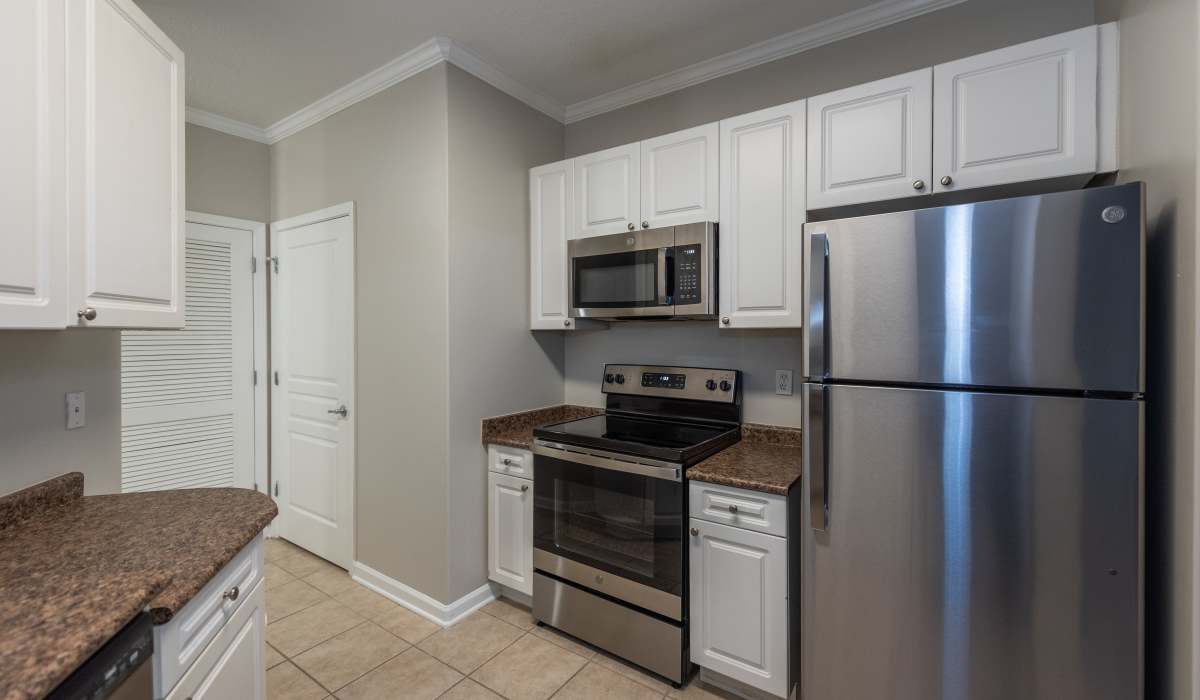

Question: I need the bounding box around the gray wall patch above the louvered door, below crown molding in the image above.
[186,124,271,221]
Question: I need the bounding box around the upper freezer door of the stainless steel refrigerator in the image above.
[805,183,1144,394]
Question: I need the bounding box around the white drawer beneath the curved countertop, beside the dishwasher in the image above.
[154,534,263,698]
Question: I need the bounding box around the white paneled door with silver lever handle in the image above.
[271,204,354,568]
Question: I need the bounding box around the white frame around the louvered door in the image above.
[184,211,270,493]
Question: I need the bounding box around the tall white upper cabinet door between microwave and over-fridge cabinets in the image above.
[719,100,805,328]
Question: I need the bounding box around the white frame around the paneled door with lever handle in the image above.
[268,202,359,563]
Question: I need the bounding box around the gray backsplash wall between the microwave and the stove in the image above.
[564,321,803,427]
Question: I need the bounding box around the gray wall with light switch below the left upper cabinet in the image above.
[0,329,121,495]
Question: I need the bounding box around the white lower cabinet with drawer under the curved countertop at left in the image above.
[154,534,266,700]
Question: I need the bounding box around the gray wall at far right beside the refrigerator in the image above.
[1097,0,1200,700]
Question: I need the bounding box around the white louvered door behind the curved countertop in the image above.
[121,222,254,491]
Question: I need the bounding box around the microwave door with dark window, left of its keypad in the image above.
[568,227,674,318]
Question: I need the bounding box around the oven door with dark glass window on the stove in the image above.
[533,444,686,621]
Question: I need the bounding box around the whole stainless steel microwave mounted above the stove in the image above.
[568,222,716,318]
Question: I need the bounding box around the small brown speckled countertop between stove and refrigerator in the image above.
[688,423,800,496]
